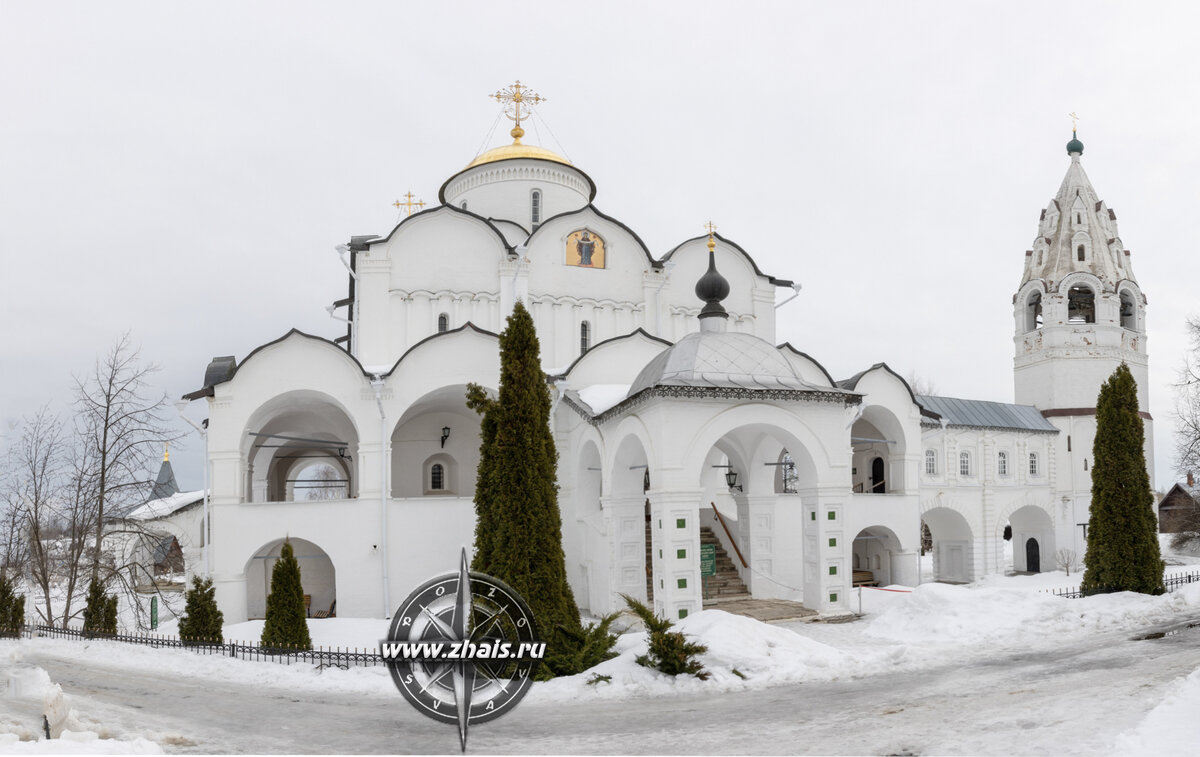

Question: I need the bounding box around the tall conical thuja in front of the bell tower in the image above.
[1081,362,1163,594]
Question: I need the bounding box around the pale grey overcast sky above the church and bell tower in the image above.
[0,0,1200,488]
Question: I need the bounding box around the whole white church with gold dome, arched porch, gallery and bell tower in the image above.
[168,83,1153,623]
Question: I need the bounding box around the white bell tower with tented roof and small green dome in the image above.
[1013,132,1154,559]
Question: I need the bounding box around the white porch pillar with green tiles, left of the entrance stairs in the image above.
[649,489,703,620]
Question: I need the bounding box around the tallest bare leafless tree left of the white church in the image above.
[76,332,178,581]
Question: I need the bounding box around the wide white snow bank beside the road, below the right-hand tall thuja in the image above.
[864,583,1200,647]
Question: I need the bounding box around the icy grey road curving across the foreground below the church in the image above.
[11,630,1200,755]
